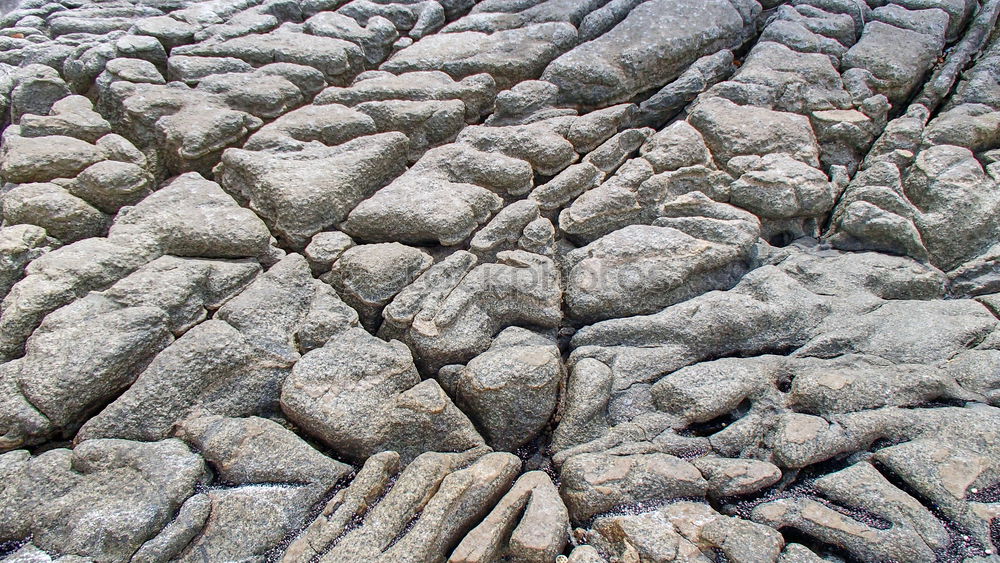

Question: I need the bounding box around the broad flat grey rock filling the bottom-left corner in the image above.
[0,440,209,560]
